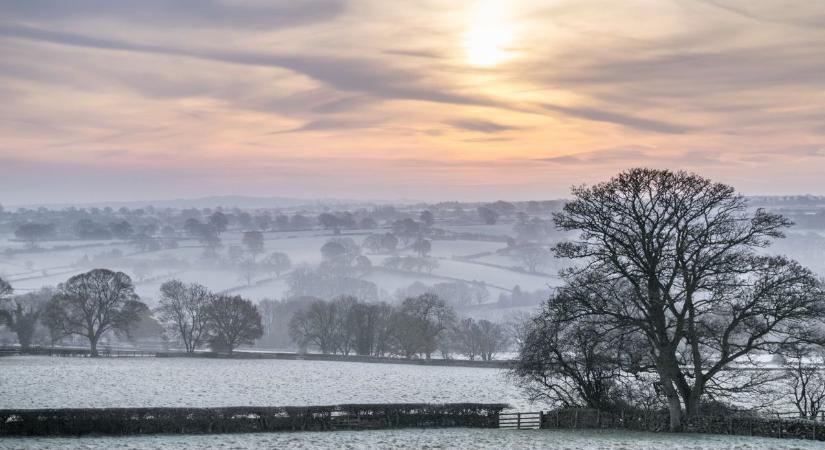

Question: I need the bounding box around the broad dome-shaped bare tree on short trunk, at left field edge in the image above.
[43,269,146,356]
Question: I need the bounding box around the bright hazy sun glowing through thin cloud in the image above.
[463,1,512,67]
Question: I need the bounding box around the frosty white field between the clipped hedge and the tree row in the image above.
[0,356,539,410]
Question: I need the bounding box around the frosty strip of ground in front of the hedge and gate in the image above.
[0,428,823,450]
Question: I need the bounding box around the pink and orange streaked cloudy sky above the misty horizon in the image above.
[0,0,825,205]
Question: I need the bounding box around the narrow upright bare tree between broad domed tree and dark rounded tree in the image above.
[157,280,213,353]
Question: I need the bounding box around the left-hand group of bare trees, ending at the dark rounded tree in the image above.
[0,269,263,356]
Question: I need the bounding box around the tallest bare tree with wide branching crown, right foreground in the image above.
[554,169,823,431]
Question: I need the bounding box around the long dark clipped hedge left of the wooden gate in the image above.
[0,403,508,436]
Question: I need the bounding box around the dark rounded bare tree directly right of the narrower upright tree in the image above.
[206,295,263,354]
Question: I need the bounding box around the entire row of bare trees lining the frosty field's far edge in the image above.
[0,269,509,361]
